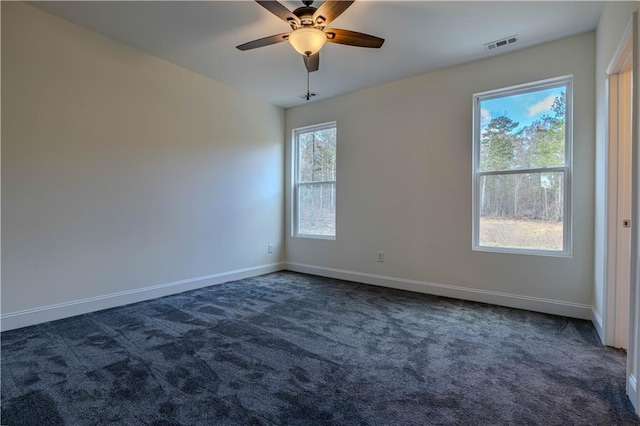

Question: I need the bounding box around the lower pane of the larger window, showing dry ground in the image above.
[478,172,564,251]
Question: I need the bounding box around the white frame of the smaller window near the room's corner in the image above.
[291,121,338,240]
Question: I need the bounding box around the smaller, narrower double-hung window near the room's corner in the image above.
[293,123,336,239]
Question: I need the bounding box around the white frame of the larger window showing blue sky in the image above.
[472,75,573,257]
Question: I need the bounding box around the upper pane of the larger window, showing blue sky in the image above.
[480,86,566,171]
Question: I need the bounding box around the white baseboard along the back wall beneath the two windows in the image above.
[286,262,592,320]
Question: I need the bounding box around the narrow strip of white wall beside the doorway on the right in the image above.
[593,1,638,343]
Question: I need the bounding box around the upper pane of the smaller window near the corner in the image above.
[298,127,336,182]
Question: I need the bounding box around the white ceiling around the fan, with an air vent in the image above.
[30,0,603,108]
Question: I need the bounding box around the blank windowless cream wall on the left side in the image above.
[2,2,284,329]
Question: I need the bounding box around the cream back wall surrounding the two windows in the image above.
[286,33,595,318]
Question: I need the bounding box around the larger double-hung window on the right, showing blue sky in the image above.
[473,76,572,256]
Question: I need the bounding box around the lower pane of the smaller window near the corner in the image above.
[298,183,336,236]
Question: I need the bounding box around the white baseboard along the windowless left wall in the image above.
[0,262,285,331]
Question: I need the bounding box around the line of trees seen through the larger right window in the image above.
[480,93,566,221]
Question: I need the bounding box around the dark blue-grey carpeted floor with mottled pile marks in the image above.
[1,272,640,426]
